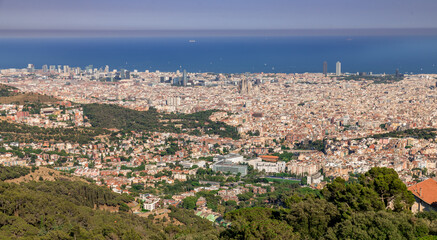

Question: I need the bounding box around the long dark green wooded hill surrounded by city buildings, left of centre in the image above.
[83,104,240,139]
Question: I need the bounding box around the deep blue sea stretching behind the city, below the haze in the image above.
[0,36,437,73]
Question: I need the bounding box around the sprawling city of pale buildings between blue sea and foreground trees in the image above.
[0,62,437,239]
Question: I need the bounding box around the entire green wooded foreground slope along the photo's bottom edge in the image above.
[0,167,437,240]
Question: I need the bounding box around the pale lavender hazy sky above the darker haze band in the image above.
[0,0,437,30]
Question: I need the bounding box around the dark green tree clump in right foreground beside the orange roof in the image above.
[221,168,430,240]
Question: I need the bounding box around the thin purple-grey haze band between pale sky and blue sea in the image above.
[0,28,437,38]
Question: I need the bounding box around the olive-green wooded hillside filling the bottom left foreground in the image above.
[0,167,218,240]
